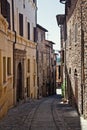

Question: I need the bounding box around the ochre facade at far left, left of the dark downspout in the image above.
[0,1,13,118]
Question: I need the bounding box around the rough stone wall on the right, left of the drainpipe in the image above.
[66,0,82,113]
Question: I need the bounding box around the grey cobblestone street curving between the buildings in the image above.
[0,96,87,130]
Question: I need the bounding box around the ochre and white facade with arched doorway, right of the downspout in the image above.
[14,0,37,102]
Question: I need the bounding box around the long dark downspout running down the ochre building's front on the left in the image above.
[12,0,16,104]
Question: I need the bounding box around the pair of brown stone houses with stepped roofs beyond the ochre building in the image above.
[37,24,55,97]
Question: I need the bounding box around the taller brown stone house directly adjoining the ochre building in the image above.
[37,24,47,97]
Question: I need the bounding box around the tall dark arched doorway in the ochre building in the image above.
[17,63,23,101]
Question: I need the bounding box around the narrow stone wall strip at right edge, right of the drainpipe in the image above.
[81,0,87,118]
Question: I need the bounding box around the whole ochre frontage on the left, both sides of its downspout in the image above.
[0,0,37,117]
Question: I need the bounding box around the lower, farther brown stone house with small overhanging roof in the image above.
[45,40,56,95]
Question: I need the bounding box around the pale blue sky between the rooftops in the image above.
[37,0,64,50]
